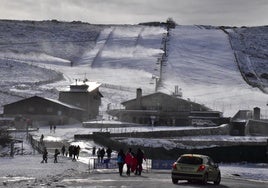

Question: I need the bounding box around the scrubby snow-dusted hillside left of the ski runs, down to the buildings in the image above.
[0,20,105,112]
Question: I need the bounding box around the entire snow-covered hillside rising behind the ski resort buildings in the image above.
[0,20,268,116]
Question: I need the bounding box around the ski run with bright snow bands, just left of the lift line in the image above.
[78,26,166,92]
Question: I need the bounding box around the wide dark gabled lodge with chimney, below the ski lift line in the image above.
[108,89,224,126]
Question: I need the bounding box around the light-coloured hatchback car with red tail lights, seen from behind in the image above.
[171,154,221,185]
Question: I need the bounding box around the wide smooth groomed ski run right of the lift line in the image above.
[161,26,267,116]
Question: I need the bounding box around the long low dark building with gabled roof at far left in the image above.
[4,96,86,128]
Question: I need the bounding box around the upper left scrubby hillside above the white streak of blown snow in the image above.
[0,20,103,61]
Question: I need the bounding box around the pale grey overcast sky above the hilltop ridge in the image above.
[0,0,268,26]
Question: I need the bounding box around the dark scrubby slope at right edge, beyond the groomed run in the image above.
[229,26,268,93]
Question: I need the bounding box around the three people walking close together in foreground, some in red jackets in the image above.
[117,148,146,176]
